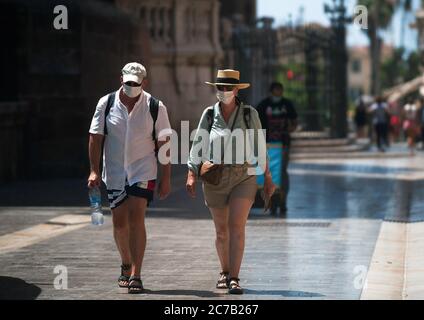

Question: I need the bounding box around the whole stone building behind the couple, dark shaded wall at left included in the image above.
[0,0,260,183]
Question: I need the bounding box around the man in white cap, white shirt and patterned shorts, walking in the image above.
[88,63,172,293]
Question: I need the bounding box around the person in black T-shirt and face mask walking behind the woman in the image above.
[257,82,297,216]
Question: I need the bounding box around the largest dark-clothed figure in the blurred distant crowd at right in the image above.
[369,97,390,152]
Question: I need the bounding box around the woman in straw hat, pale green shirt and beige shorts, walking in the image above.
[186,70,275,294]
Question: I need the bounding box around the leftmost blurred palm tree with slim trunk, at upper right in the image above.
[358,0,399,95]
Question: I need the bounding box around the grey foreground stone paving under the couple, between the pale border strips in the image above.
[0,214,380,299]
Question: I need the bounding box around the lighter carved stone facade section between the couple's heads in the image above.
[116,0,222,131]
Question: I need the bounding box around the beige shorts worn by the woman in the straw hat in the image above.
[203,165,258,208]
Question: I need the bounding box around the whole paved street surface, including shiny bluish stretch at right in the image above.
[0,145,424,300]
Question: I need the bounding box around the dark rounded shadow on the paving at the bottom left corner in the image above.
[0,276,41,300]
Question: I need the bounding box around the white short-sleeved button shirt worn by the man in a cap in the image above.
[89,88,172,190]
